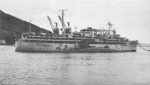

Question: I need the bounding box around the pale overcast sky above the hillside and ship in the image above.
[0,0,150,43]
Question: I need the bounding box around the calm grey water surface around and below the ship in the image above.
[0,46,150,85]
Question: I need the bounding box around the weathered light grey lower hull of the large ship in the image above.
[15,40,138,53]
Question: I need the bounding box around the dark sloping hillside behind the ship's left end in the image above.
[0,10,50,44]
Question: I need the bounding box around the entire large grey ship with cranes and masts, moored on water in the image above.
[15,10,138,53]
